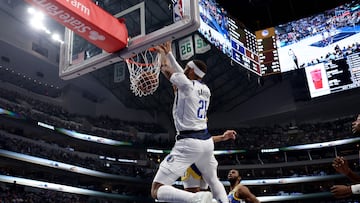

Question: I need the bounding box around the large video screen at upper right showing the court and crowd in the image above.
[275,1,360,72]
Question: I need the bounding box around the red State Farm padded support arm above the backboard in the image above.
[25,0,128,53]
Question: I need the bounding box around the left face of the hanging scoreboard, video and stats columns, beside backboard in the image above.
[199,0,261,75]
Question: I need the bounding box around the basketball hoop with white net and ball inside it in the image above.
[125,48,161,97]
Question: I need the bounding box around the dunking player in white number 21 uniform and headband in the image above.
[151,42,228,203]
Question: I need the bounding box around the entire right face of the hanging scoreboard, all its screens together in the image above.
[264,0,360,98]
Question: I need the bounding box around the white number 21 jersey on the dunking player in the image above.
[170,72,211,133]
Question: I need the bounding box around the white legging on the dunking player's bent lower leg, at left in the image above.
[157,185,195,203]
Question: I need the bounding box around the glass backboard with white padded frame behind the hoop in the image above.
[59,0,200,80]
